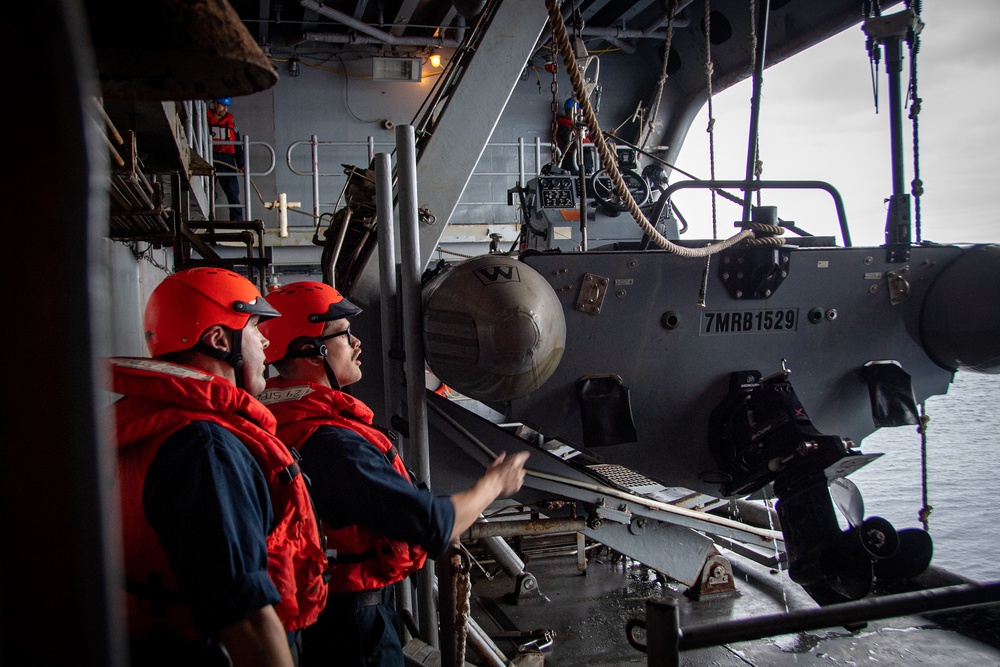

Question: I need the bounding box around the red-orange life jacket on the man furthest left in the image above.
[112,358,328,639]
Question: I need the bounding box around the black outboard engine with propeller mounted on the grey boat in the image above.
[703,370,932,604]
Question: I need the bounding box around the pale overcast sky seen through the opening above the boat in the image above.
[675,0,1000,246]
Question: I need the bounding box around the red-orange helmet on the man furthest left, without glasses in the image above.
[143,267,281,357]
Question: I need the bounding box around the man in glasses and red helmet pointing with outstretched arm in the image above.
[261,282,527,666]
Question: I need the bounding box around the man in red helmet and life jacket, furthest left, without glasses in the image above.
[112,268,327,665]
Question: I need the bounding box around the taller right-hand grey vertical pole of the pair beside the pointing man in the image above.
[396,125,438,648]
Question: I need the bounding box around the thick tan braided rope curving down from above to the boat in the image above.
[545,0,753,257]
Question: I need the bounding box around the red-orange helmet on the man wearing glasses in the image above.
[260,281,361,364]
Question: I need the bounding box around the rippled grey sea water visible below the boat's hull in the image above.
[850,371,1000,581]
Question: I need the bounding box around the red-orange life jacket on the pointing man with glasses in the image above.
[260,377,427,593]
